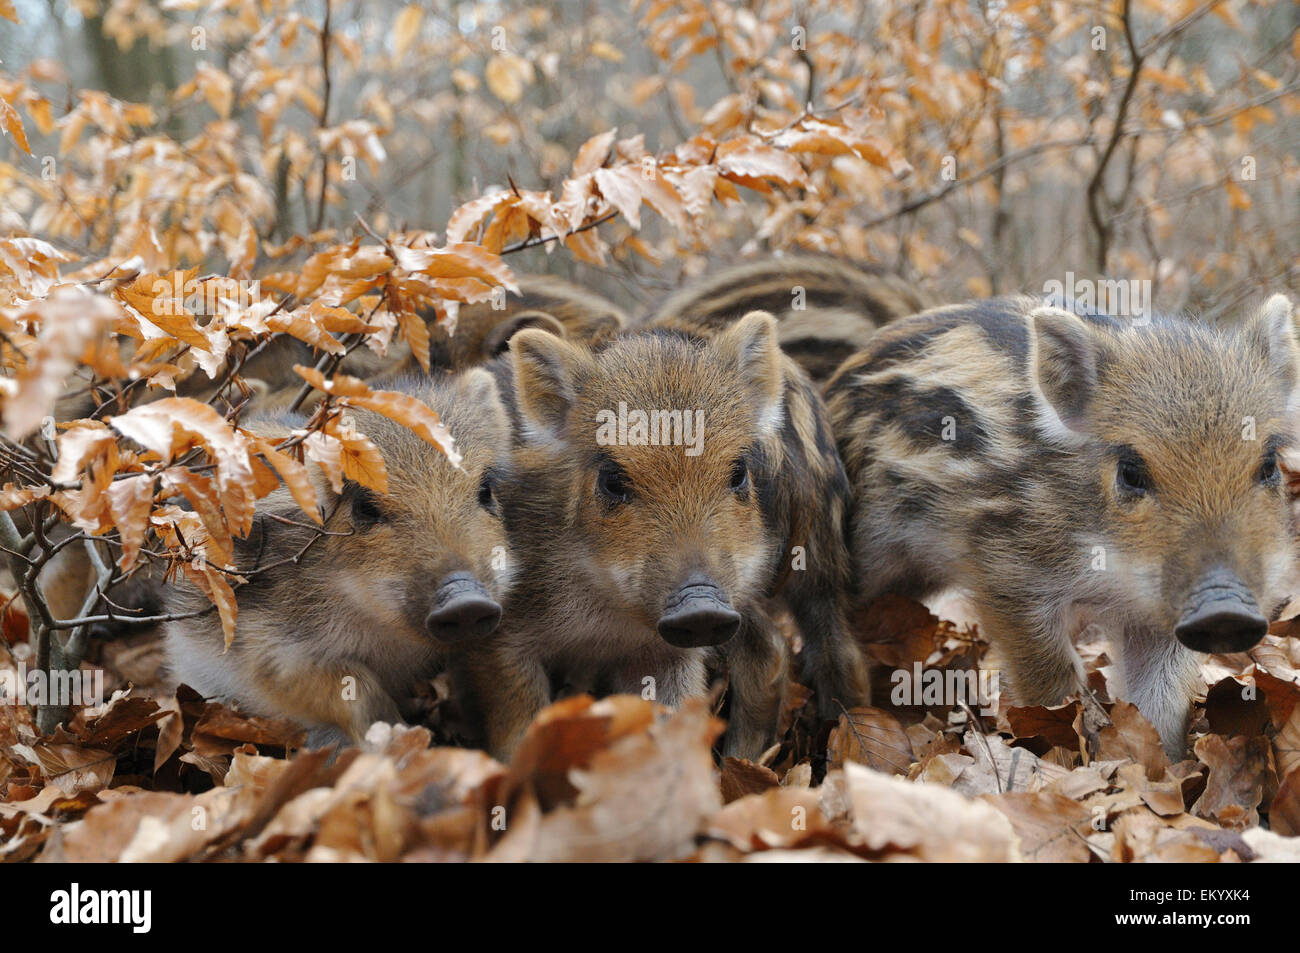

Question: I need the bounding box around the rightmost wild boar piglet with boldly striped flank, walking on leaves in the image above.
[827,295,1297,757]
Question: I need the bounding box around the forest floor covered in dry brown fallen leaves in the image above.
[0,599,1300,862]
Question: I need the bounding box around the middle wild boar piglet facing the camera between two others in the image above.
[458,312,867,757]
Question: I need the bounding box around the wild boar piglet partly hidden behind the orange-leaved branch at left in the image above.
[166,369,511,745]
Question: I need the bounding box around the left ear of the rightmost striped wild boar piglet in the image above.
[1027,306,1097,442]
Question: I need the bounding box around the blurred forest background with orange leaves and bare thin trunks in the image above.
[0,0,1300,316]
